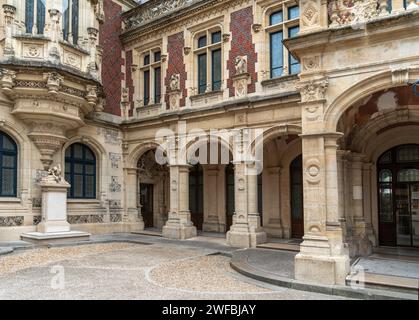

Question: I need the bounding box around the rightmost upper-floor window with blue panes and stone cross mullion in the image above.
[266,2,300,79]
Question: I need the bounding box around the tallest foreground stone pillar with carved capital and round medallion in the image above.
[295,79,349,285]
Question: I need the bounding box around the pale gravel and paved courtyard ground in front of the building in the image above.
[0,243,348,299]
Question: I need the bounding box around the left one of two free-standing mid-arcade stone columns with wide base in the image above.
[163,164,197,240]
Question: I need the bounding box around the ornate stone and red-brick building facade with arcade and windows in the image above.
[0,0,419,284]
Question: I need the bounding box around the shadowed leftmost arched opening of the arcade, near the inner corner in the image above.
[137,149,169,229]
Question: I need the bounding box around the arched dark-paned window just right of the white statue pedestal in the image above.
[65,143,96,199]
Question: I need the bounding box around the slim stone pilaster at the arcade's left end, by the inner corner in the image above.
[124,168,144,232]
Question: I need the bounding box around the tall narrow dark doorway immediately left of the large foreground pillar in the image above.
[290,155,304,238]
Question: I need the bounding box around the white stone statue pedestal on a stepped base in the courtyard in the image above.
[21,178,90,244]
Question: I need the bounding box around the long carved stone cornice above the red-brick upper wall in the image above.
[120,0,253,45]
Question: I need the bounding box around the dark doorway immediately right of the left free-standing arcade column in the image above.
[189,164,204,230]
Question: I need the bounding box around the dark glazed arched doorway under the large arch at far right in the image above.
[377,145,419,247]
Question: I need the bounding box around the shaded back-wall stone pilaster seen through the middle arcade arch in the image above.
[202,165,222,232]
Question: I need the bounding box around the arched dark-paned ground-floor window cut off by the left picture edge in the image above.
[0,132,17,197]
